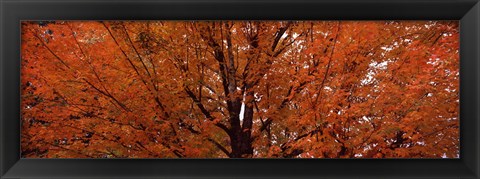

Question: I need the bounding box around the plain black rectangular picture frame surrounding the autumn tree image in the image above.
[0,0,480,179]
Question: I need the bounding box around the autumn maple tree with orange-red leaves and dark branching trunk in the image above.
[21,21,460,158]
